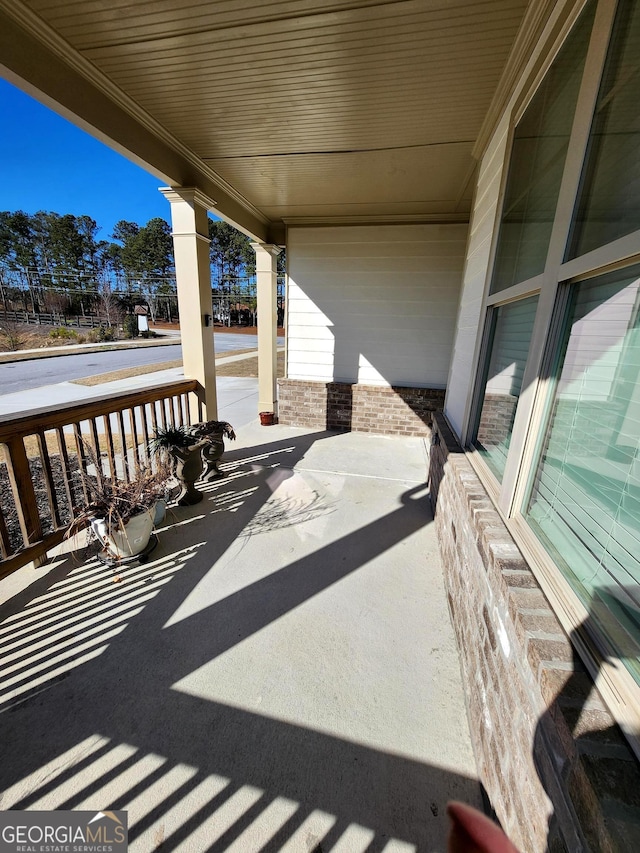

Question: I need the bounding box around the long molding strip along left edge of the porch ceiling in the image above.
[0,0,269,231]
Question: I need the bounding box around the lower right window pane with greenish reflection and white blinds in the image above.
[525,267,640,682]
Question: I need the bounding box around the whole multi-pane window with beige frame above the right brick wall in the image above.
[468,0,640,736]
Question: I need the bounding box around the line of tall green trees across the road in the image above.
[0,210,284,324]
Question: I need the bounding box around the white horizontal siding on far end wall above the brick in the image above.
[287,225,467,388]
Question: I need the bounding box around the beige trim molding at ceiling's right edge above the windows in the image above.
[472,0,585,160]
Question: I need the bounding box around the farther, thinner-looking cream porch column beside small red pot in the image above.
[251,243,281,416]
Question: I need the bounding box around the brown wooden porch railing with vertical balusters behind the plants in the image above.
[0,380,202,578]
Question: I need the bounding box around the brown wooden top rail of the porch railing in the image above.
[0,379,198,442]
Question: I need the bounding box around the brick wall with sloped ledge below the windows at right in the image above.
[430,414,640,853]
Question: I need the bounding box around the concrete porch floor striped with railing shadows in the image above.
[0,423,481,853]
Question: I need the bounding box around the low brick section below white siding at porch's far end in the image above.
[278,379,445,436]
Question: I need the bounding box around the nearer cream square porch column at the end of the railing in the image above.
[160,187,218,421]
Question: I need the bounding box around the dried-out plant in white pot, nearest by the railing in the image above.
[67,463,170,562]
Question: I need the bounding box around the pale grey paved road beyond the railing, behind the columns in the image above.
[0,332,258,395]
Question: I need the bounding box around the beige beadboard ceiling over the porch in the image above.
[0,0,540,243]
